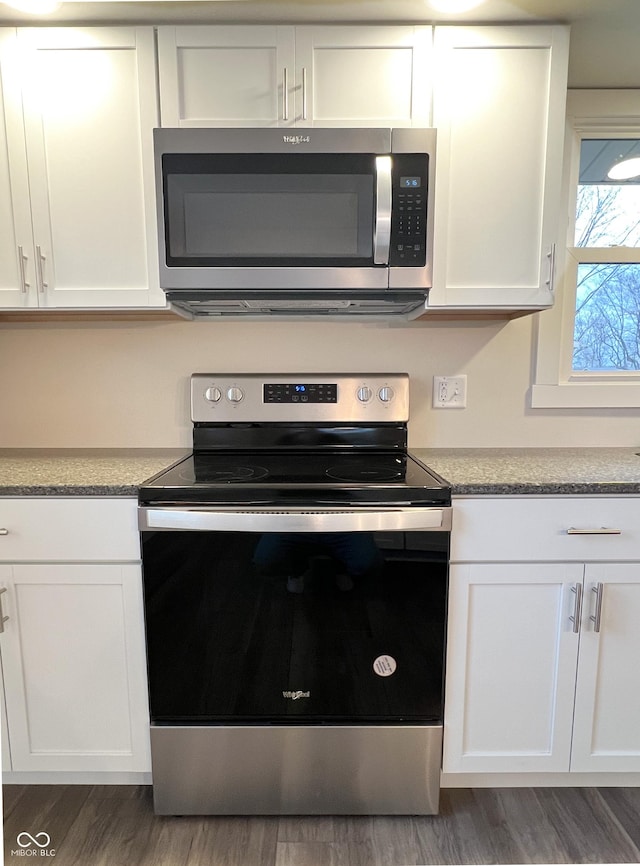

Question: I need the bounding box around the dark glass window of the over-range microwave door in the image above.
[162,154,375,267]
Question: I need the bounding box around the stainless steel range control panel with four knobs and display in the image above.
[191,373,409,424]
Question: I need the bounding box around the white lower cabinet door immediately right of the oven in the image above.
[443,563,583,773]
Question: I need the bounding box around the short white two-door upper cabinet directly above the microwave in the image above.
[158,25,432,127]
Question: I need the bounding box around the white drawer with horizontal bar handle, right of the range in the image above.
[451,496,640,562]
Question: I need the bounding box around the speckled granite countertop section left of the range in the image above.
[0,448,189,496]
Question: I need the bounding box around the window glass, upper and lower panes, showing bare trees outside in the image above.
[572,139,640,372]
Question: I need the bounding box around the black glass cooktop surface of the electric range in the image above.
[140,451,451,503]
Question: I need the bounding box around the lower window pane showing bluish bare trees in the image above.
[573,264,640,372]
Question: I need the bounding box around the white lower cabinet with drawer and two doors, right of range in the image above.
[443,497,640,773]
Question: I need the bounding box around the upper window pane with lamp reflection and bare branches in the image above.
[574,139,640,247]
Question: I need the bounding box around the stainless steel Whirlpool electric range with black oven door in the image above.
[139,373,451,814]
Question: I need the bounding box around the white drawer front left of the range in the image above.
[0,497,140,562]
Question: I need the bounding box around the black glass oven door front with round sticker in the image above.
[143,532,448,724]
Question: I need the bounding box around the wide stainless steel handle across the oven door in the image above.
[138,506,451,532]
